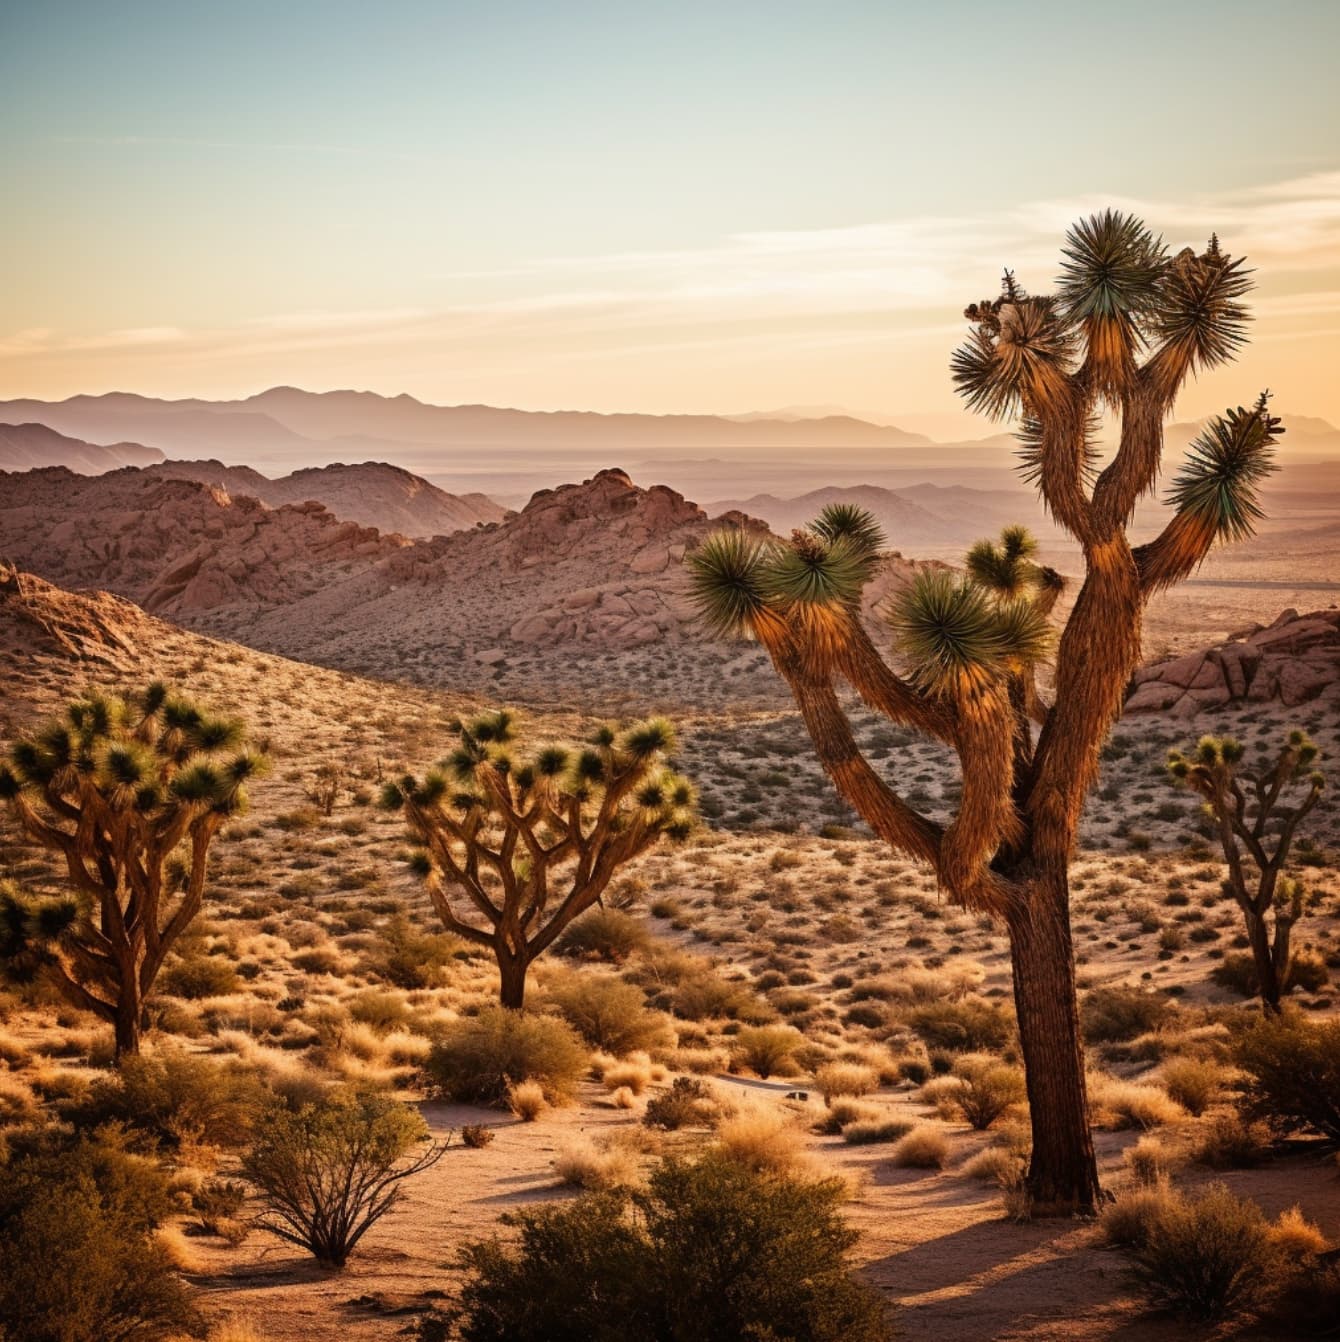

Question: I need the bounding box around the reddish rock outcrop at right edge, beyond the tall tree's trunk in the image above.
[1125,608,1340,717]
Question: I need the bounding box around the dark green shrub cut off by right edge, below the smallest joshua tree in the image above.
[1234,1013,1340,1142]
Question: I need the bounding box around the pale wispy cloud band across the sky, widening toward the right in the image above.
[10,170,1340,386]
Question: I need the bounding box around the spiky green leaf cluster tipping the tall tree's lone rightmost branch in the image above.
[1168,393,1284,541]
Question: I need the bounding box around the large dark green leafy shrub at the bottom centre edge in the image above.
[460,1155,889,1342]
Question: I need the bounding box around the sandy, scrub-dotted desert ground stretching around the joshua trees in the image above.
[0,539,1340,1342]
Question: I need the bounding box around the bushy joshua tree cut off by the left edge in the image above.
[0,684,263,1057]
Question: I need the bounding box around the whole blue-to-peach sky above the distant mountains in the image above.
[0,0,1340,433]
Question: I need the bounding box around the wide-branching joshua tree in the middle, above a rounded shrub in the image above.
[382,709,693,1007]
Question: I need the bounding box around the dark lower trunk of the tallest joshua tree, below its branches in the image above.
[1009,867,1099,1216]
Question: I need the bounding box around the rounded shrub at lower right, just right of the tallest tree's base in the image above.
[1131,1184,1281,1322]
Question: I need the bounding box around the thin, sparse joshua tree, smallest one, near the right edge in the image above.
[1168,730,1327,1016]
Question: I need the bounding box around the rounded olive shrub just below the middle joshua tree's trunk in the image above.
[424,1007,588,1104]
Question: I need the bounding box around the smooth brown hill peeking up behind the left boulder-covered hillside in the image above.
[142,460,506,538]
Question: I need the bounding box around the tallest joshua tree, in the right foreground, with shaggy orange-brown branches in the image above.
[692,212,1278,1213]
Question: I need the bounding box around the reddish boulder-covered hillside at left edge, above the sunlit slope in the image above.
[0,467,409,617]
